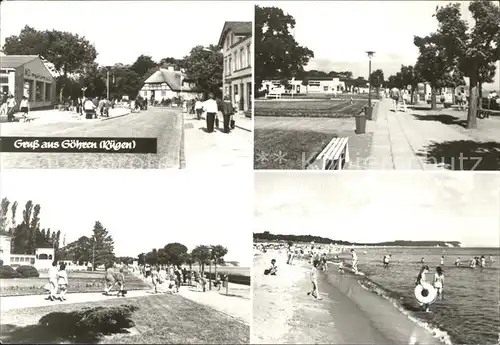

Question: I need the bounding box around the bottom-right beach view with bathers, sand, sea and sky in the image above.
[251,172,500,345]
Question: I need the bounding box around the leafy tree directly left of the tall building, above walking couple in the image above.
[184,45,224,97]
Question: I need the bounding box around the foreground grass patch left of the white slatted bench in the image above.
[254,128,335,170]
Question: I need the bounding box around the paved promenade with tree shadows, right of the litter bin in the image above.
[363,99,500,170]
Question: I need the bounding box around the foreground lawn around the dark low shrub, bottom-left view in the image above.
[0,294,250,344]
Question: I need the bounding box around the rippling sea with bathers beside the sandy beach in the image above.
[340,247,500,345]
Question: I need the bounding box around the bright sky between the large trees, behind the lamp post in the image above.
[259,0,500,90]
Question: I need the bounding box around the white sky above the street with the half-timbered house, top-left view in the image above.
[0,1,254,65]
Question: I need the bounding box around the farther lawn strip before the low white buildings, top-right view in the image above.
[255,100,366,118]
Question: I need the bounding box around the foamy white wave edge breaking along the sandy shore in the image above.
[358,275,453,345]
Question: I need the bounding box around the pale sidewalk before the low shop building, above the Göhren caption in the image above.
[0,108,130,124]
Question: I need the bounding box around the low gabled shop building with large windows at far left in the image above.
[0,55,56,109]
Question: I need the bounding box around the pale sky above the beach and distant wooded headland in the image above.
[254,171,500,247]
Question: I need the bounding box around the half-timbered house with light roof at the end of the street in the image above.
[139,67,199,101]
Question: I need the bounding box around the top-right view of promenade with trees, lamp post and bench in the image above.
[254,1,500,171]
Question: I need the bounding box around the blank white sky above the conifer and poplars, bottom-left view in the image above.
[0,170,253,267]
